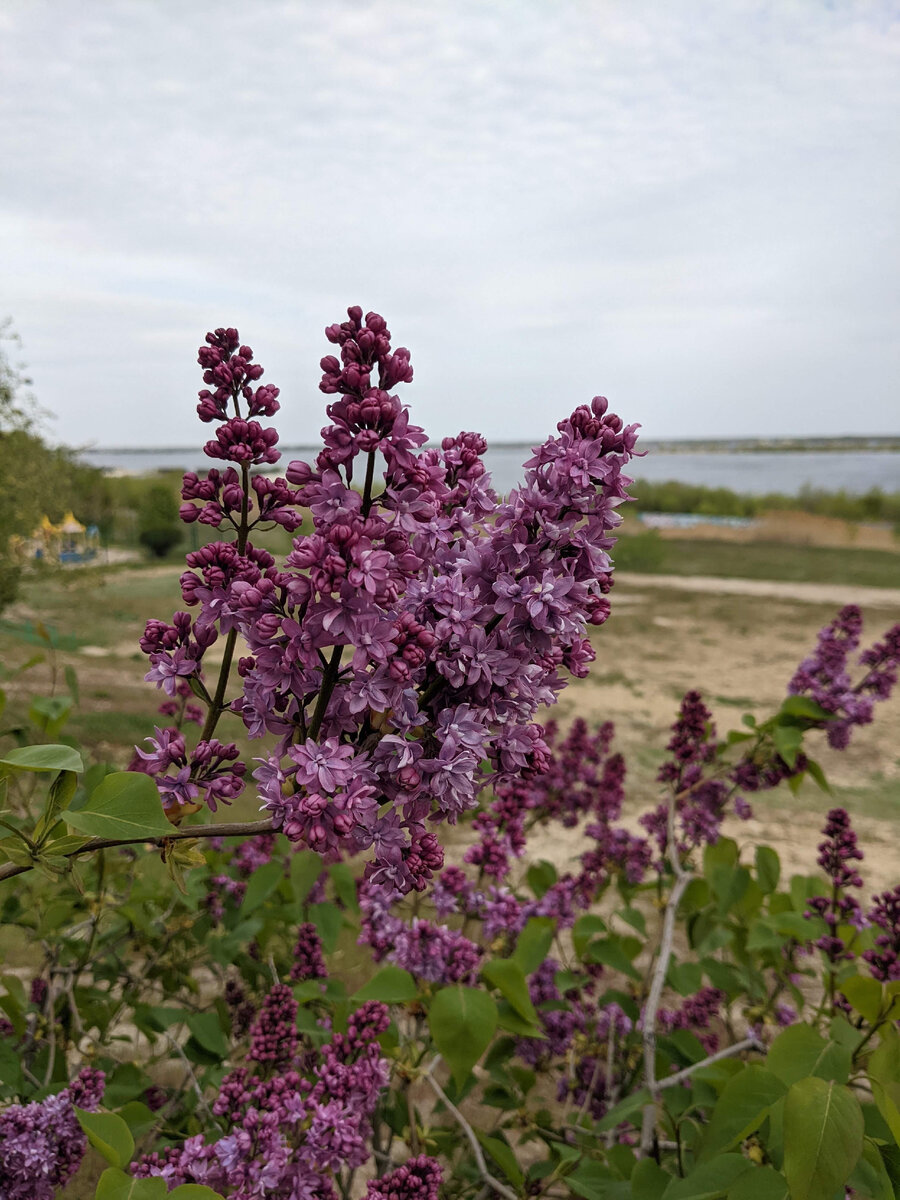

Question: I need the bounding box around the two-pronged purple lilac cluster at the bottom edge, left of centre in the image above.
[132,985,388,1200]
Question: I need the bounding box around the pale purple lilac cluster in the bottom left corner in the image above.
[0,1068,106,1200]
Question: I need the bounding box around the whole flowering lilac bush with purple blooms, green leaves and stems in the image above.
[0,308,900,1200]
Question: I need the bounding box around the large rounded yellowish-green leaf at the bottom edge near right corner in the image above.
[785,1079,863,1200]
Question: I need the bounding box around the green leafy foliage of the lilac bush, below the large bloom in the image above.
[0,609,900,1200]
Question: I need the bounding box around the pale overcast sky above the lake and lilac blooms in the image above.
[0,0,900,446]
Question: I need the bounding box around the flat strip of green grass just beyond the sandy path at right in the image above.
[613,534,900,588]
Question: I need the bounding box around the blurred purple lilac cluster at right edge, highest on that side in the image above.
[788,605,900,750]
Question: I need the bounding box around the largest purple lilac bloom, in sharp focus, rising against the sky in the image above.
[142,308,635,893]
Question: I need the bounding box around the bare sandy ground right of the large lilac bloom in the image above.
[528,572,900,890]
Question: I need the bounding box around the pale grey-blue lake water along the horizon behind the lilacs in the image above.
[80,445,900,496]
